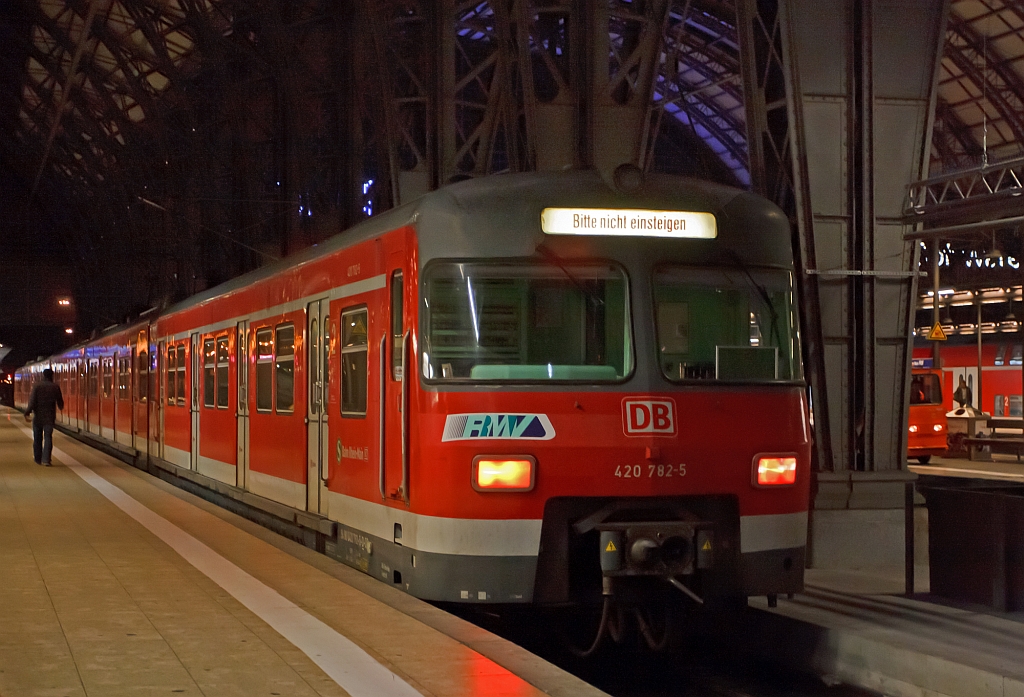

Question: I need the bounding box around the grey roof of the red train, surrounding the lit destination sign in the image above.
[18,170,792,367]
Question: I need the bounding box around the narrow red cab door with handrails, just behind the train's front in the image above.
[380,264,409,504]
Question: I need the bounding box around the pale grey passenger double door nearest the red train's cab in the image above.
[306,298,330,516]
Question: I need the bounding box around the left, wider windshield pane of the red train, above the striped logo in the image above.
[423,263,633,383]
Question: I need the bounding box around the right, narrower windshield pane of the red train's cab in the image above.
[654,267,802,382]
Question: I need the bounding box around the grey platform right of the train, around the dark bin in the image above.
[727,454,1024,697]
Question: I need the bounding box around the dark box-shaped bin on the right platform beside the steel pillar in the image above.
[921,486,1024,612]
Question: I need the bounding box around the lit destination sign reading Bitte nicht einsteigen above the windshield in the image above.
[541,208,718,239]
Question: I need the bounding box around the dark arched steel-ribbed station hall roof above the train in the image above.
[0,0,1024,329]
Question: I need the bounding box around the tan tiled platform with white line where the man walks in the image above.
[0,408,604,697]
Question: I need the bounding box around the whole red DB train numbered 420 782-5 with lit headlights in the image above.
[16,172,810,618]
